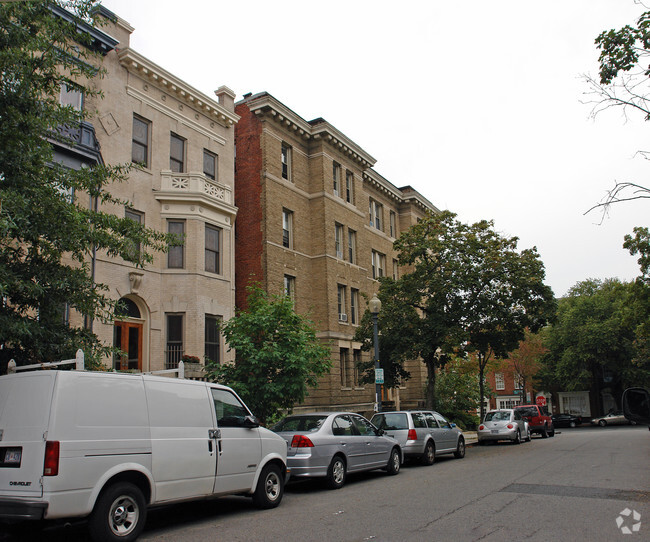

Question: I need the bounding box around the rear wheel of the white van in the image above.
[88,482,147,542]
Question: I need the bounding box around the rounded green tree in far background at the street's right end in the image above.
[541,279,650,410]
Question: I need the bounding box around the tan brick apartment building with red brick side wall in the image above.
[235,93,437,413]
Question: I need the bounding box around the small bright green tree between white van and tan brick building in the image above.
[206,284,331,423]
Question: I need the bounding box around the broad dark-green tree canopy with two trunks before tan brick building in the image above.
[352,211,555,416]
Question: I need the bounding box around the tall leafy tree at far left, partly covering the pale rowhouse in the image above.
[0,0,167,372]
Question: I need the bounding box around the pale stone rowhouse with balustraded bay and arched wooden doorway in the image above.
[63,8,238,371]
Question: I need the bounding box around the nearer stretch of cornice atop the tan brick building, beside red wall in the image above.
[239,92,377,169]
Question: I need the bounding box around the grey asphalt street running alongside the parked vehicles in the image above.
[5,426,650,542]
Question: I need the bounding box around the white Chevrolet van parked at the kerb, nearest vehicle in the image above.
[0,370,288,542]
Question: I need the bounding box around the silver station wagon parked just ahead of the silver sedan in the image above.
[371,410,465,465]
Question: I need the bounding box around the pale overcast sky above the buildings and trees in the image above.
[103,0,650,296]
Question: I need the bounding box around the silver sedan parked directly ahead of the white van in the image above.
[272,412,403,489]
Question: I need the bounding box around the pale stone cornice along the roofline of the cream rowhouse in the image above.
[117,48,239,128]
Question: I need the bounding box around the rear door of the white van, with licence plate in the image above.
[0,371,57,498]
